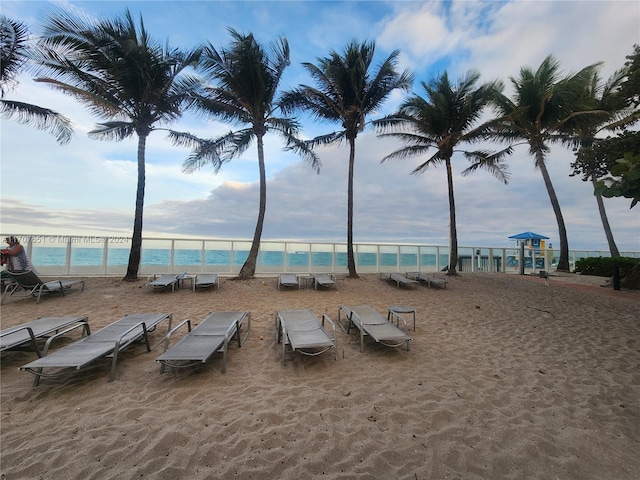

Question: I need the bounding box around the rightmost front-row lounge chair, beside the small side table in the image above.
[338,305,411,352]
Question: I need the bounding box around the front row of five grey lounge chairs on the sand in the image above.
[0,305,415,387]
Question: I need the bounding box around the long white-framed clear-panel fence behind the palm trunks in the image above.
[2,235,640,276]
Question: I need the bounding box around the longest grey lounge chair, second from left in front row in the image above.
[20,313,173,387]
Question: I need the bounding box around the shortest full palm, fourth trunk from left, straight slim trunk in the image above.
[373,71,511,275]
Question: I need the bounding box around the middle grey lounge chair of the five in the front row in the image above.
[156,312,251,373]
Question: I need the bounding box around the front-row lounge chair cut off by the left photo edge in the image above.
[0,317,91,357]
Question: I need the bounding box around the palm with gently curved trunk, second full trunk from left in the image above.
[175,29,320,279]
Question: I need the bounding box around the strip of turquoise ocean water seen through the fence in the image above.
[31,247,448,267]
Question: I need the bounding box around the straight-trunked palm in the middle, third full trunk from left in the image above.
[283,41,413,278]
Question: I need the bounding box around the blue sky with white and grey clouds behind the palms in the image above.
[0,0,640,252]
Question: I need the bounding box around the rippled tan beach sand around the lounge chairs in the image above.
[0,273,640,480]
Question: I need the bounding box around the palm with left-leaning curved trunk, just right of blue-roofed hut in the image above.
[495,55,601,272]
